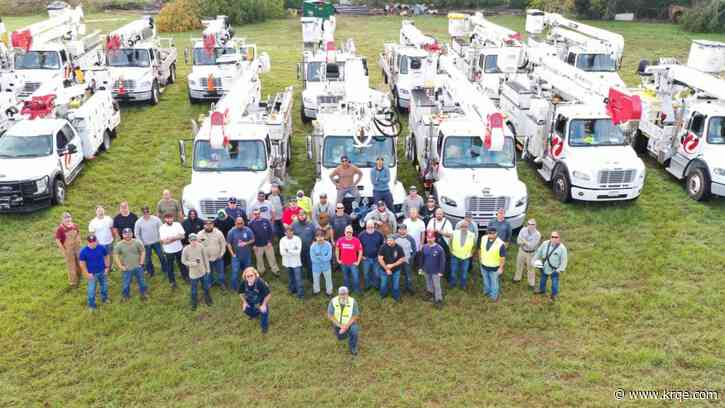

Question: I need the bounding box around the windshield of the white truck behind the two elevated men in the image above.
[322,136,395,168]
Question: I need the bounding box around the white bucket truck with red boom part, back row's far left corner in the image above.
[1,2,102,99]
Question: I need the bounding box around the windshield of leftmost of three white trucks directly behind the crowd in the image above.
[194,140,267,171]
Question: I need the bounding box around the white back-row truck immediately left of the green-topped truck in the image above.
[184,16,269,103]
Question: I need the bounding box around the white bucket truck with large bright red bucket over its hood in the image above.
[501,52,645,202]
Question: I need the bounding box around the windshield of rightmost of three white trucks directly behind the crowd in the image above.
[443,136,514,168]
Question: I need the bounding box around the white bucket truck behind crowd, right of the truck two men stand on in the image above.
[406,56,528,230]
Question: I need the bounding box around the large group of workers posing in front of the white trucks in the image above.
[55,177,567,354]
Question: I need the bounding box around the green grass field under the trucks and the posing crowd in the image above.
[0,14,725,407]
